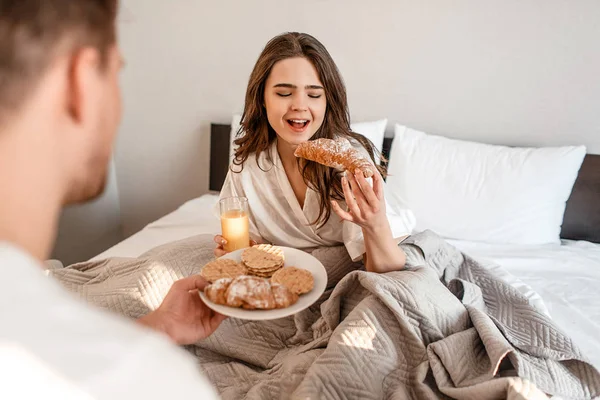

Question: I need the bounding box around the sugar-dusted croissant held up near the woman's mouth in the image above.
[294,138,373,178]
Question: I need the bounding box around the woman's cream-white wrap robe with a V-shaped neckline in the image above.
[215,141,415,261]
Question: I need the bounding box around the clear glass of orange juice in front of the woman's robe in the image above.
[219,197,250,253]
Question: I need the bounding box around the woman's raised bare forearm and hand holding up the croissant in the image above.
[332,171,406,273]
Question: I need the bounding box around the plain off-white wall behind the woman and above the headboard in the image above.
[116,0,600,234]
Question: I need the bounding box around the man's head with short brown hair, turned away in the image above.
[0,0,122,203]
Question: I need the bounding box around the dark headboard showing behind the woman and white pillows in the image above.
[209,124,600,243]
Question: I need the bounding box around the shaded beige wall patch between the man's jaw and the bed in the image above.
[52,158,123,265]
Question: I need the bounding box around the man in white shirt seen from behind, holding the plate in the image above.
[0,0,224,399]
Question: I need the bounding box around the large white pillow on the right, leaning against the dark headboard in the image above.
[387,125,586,244]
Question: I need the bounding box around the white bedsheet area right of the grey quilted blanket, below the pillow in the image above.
[449,240,600,369]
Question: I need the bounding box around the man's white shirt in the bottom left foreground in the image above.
[0,242,217,399]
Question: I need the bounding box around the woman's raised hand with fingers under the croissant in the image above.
[331,170,389,233]
